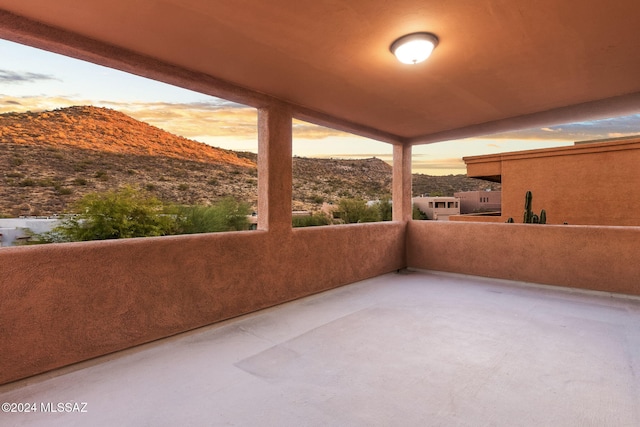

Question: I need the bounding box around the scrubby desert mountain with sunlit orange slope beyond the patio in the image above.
[0,106,495,216]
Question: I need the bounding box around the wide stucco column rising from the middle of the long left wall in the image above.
[258,105,293,231]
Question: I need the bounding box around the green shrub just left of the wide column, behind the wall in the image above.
[176,197,251,234]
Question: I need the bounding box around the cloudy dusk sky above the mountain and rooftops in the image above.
[0,40,640,175]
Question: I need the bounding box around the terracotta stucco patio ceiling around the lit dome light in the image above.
[0,0,640,143]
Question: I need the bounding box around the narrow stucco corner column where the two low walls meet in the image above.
[393,144,412,221]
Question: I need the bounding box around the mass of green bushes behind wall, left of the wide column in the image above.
[28,186,250,244]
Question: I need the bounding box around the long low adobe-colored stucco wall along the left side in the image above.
[0,222,405,384]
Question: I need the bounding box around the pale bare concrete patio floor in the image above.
[0,271,640,426]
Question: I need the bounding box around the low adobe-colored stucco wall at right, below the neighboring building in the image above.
[407,221,640,295]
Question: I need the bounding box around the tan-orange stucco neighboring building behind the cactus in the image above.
[464,138,640,226]
